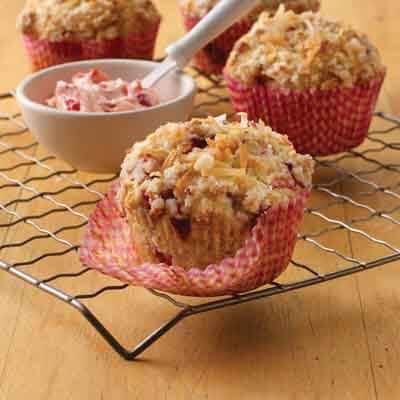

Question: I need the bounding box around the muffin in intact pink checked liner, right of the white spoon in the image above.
[225,7,386,156]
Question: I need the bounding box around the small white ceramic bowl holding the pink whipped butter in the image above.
[16,60,196,173]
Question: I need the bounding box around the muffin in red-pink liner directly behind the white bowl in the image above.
[17,0,161,70]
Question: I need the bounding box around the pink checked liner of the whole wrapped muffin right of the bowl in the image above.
[225,73,385,156]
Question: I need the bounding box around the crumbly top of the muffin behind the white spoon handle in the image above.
[180,0,320,18]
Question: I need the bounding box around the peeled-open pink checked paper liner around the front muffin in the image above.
[80,182,309,297]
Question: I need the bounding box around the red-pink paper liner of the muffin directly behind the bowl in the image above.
[22,21,160,71]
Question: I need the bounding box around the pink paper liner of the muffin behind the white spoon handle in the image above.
[182,11,253,75]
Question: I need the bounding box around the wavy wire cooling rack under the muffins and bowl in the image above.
[0,70,400,360]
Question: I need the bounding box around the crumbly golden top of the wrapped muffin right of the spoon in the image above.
[226,6,385,89]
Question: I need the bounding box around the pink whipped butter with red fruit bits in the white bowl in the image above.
[46,69,160,112]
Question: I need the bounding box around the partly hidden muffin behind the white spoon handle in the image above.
[180,0,320,74]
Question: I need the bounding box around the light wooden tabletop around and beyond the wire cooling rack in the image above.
[0,0,400,400]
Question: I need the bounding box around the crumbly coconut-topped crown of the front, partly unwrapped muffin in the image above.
[120,114,314,221]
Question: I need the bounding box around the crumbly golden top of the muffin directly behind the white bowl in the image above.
[17,0,160,41]
